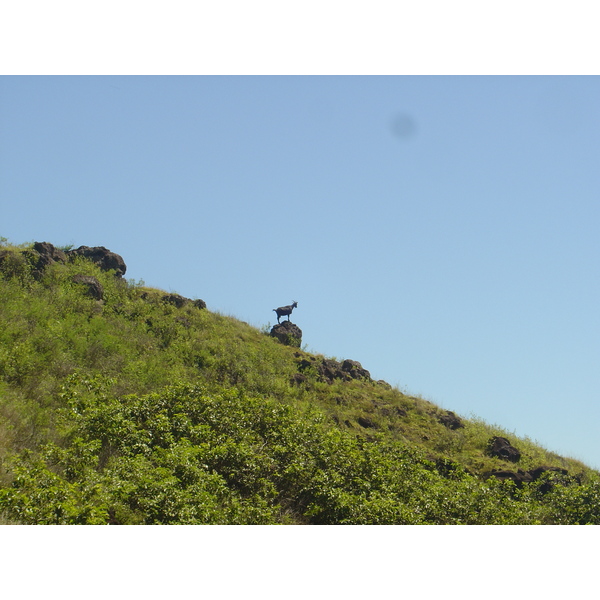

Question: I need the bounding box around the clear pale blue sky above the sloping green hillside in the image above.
[0,76,600,468]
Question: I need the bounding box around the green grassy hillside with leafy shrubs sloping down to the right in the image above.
[0,242,600,524]
